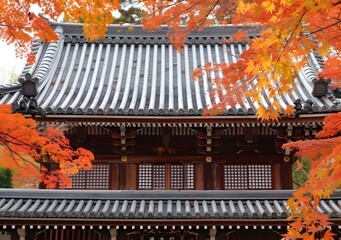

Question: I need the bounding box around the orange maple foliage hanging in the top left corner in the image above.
[0,0,119,63]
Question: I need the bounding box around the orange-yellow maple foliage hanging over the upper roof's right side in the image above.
[143,0,341,121]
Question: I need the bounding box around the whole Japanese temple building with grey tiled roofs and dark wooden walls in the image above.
[0,22,341,240]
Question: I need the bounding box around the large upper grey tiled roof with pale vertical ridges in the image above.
[0,23,339,116]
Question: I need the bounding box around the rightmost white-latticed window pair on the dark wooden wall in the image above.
[224,164,272,189]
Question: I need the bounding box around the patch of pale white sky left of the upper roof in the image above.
[0,42,25,85]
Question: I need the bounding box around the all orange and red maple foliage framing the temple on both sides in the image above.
[0,0,341,239]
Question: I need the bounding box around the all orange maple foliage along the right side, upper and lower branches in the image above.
[139,0,341,240]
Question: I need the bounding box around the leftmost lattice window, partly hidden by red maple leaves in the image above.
[66,164,110,189]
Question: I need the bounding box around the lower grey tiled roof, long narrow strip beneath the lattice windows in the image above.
[0,189,341,220]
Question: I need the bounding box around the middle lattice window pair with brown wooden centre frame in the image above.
[138,164,194,189]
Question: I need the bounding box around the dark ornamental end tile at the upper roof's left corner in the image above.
[12,73,46,117]
